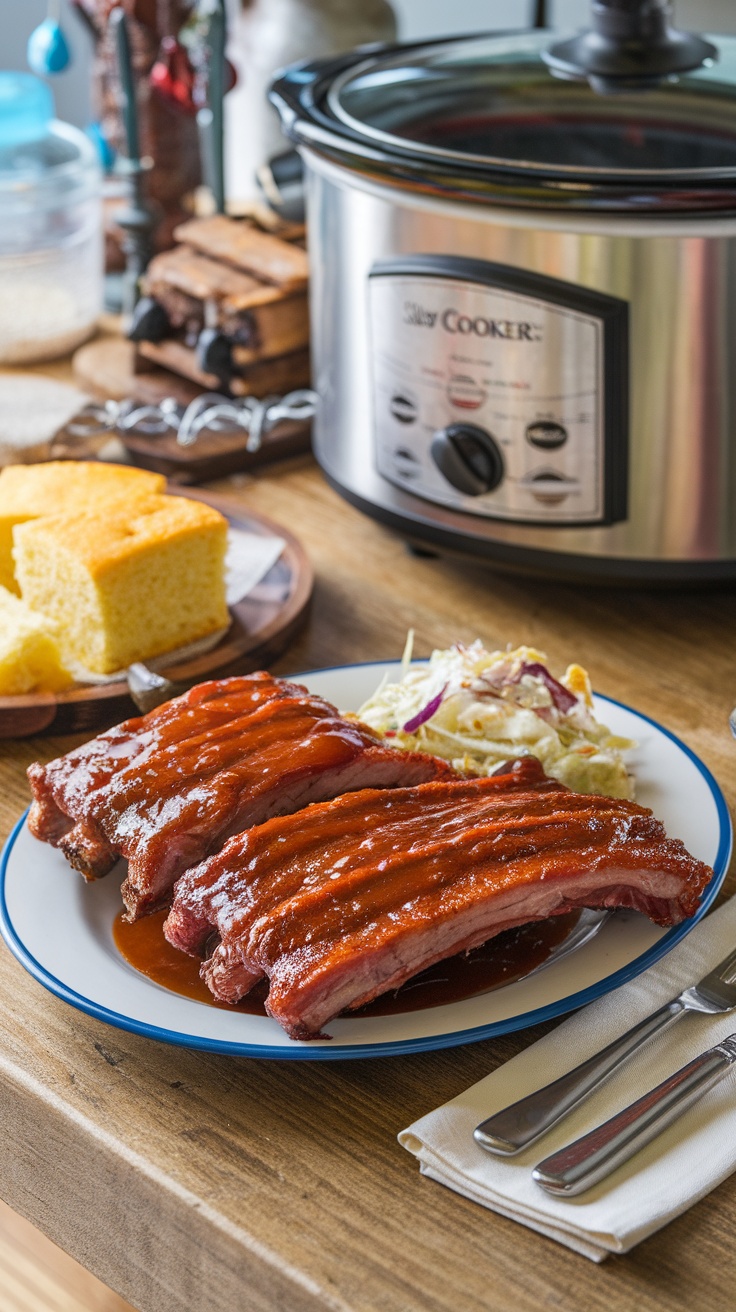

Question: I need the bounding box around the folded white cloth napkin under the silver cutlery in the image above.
[399,897,736,1262]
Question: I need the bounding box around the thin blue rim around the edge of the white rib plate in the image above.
[0,682,733,1061]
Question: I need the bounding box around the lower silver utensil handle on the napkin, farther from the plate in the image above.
[531,1044,736,1197]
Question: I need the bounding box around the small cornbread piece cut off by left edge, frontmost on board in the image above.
[0,588,72,697]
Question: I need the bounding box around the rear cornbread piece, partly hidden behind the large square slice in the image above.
[0,461,167,592]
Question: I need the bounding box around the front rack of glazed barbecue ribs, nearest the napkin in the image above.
[164,757,712,1039]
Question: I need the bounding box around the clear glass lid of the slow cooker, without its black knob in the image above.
[327,31,736,180]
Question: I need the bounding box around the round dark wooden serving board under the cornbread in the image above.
[0,487,314,739]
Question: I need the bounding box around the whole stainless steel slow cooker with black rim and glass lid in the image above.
[272,0,736,583]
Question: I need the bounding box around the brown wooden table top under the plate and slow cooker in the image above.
[0,458,736,1312]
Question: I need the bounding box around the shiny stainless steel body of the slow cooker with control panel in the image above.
[303,148,736,581]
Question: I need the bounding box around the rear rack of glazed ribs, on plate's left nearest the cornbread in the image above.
[29,673,454,920]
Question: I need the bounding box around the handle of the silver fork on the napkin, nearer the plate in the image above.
[474,998,685,1157]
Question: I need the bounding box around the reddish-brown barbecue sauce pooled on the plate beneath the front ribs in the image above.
[113,911,580,1015]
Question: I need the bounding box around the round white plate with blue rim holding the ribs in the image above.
[0,663,732,1061]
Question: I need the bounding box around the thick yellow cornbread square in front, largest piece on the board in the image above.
[13,496,228,674]
